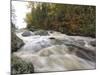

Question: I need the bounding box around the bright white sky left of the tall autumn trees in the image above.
[12,1,29,29]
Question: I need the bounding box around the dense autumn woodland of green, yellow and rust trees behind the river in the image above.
[25,2,96,37]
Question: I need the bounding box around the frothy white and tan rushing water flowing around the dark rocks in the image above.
[14,29,95,72]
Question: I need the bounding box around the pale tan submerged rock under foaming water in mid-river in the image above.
[38,45,68,56]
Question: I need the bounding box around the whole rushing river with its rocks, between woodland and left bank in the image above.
[13,30,96,72]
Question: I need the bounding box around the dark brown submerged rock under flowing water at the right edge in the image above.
[69,46,96,62]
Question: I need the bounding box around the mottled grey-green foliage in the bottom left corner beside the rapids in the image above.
[11,55,34,75]
